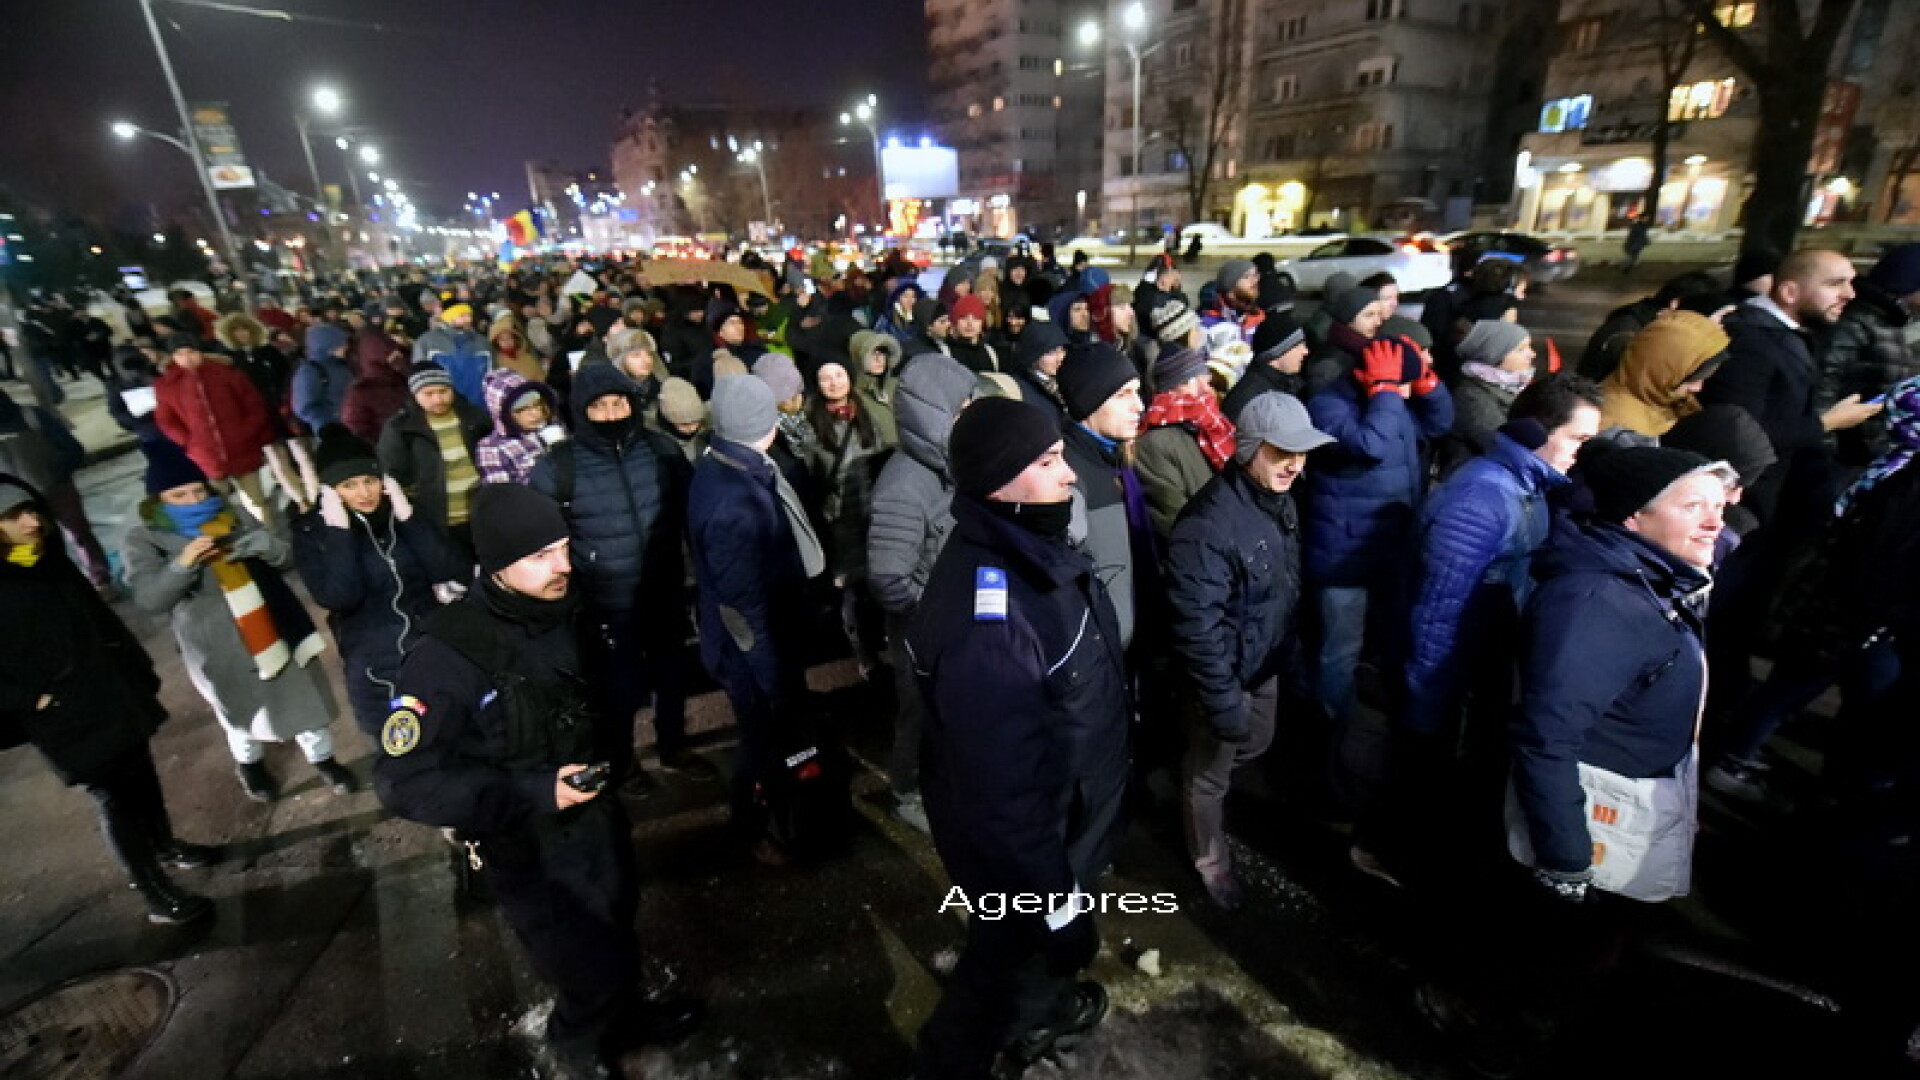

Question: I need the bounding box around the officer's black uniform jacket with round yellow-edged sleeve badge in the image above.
[374,580,601,840]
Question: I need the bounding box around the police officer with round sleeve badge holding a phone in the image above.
[374,484,699,1078]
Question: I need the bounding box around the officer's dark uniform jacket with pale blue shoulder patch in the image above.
[908,496,1131,907]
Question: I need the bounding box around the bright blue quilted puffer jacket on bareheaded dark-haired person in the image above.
[1404,432,1567,734]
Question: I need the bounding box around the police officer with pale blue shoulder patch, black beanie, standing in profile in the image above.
[908,398,1129,1080]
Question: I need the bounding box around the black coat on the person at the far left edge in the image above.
[0,477,167,784]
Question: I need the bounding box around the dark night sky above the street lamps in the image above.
[0,0,927,219]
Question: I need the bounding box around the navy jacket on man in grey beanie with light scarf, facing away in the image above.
[687,438,806,700]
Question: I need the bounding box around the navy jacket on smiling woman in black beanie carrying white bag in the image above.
[1509,515,1711,872]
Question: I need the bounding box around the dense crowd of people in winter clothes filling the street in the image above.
[0,244,1920,1078]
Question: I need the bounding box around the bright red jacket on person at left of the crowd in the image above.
[154,359,273,480]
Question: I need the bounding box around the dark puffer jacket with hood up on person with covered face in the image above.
[528,363,687,615]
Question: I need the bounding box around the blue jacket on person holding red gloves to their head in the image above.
[1306,379,1453,586]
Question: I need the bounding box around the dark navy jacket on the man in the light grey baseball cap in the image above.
[1165,465,1300,730]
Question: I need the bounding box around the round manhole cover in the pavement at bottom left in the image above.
[0,969,173,1080]
